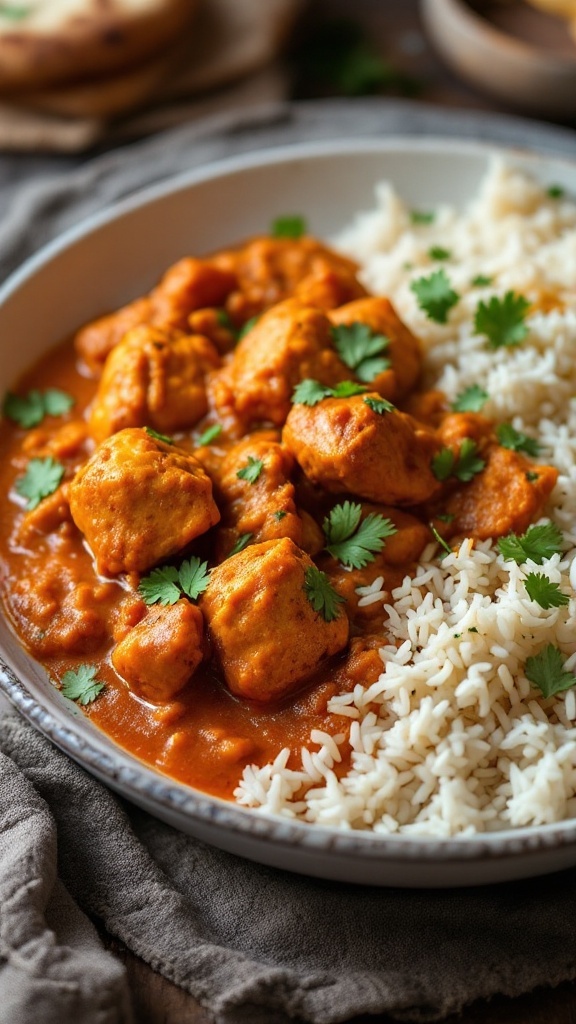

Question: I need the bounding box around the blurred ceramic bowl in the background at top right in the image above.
[421,0,576,118]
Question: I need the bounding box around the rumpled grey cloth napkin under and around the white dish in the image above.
[0,99,576,1024]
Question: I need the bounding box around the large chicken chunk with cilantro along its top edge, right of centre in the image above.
[283,394,440,505]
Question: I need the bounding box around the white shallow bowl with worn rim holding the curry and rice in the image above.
[0,138,576,886]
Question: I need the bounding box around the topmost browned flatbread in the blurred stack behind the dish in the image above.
[0,0,197,95]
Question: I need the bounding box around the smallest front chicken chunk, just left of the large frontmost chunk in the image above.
[112,600,204,703]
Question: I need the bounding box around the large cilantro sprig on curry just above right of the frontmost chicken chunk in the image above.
[322,502,398,569]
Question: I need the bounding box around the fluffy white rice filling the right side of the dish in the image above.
[235,159,576,837]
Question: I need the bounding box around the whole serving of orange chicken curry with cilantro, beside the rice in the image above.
[0,224,558,798]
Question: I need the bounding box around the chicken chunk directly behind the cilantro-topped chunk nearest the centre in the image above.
[208,300,351,426]
